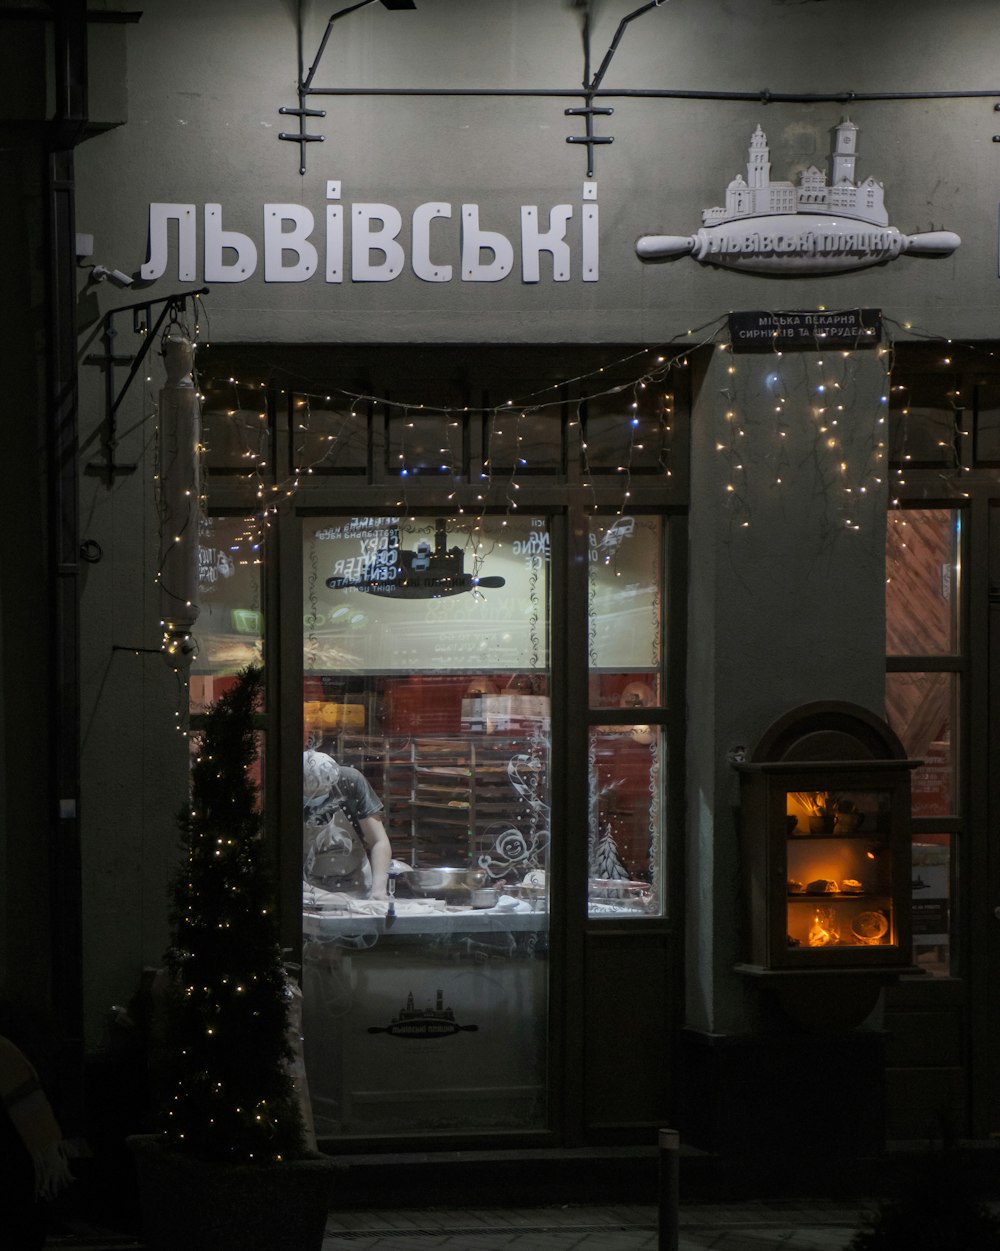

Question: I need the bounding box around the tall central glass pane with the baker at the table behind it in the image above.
[303,517,549,1137]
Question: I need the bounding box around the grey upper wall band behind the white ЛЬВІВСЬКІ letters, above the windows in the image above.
[79,0,1000,342]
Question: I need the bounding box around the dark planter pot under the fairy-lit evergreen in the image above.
[128,1133,347,1251]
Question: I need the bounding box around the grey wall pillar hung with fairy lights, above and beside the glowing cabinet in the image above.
[686,350,889,1033]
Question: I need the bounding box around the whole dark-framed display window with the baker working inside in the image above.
[190,345,688,1150]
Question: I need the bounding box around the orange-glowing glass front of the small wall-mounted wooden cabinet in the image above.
[785,791,897,951]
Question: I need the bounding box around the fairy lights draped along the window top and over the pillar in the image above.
[138,296,992,715]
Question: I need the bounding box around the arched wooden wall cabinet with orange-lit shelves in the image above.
[737,703,917,975]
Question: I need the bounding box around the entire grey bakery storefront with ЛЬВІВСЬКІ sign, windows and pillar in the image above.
[5,0,1000,1151]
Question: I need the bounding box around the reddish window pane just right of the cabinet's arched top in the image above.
[885,673,959,817]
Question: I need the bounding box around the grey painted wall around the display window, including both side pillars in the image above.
[78,0,1000,1042]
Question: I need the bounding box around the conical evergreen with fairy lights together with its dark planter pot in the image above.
[130,667,333,1251]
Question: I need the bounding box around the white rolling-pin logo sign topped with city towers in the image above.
[636,120,961,274]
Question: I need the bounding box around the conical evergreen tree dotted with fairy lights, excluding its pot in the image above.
[161,666,305,1160]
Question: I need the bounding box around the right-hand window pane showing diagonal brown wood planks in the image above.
[885,508,961,656]
